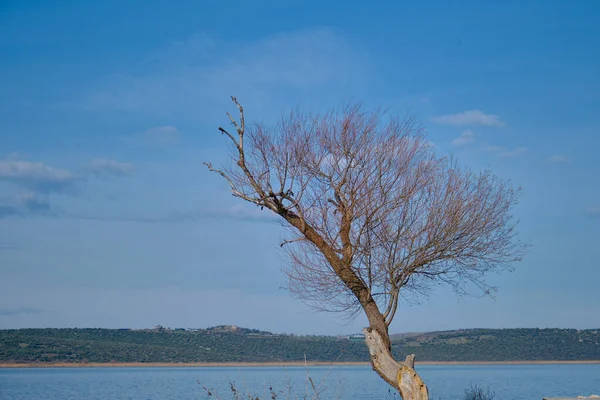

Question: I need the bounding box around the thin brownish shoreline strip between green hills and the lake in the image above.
[0,360,600,369]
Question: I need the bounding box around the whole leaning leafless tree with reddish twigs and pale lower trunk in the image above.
[206,97,525,400]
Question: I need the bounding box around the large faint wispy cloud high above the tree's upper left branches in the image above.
[77,29,372,119]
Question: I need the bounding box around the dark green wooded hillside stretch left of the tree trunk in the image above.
[0,329,368,363]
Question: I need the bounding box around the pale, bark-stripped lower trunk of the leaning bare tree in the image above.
[363,328,429,400]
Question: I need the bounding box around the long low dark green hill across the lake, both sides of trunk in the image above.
[0,326,600,363]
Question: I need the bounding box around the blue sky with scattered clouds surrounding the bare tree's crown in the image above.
[0,0,600,334]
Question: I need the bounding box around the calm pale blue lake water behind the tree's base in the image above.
[0,364,600,400]
